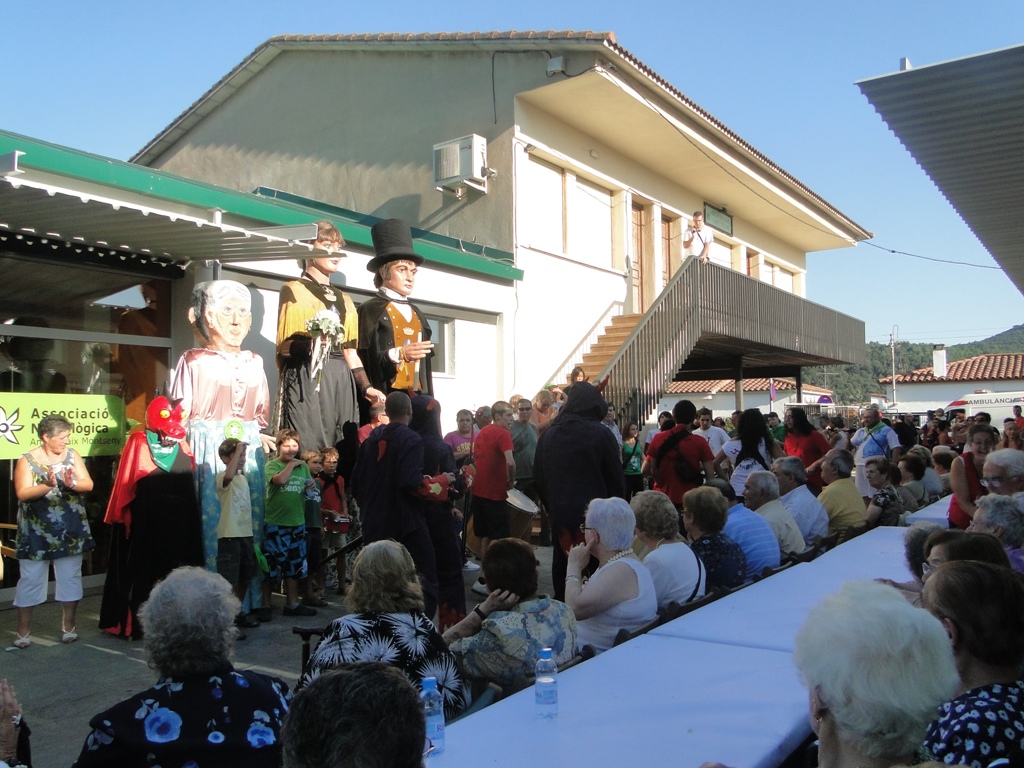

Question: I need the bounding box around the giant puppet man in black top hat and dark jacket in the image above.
[358,219,434,395]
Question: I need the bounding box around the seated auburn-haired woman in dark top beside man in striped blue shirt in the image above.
[683,485,746,590]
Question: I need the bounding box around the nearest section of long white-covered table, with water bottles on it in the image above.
[436,634,810,768]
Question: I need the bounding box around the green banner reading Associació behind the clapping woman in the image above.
[0,392,125,459]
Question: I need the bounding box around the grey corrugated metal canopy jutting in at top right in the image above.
[857,45,1024,293]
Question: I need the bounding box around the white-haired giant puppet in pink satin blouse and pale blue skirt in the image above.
[171,280,273,607]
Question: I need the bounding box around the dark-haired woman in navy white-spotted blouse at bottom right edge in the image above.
[910,561,1024,767]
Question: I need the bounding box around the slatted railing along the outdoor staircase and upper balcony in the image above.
[596,257,864,424]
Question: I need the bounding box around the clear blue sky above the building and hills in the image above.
[8,0,1024,344]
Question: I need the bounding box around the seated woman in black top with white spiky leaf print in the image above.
[298,540,468,718]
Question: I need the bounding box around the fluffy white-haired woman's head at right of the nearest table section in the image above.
[794,582,957,767]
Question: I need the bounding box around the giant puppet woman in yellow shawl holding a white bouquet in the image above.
[278,221,384,450]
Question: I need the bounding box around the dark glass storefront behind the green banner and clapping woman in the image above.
[0,256,171,587]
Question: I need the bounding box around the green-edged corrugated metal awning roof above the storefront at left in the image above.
[0,130,523,281]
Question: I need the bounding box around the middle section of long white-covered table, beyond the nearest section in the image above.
[648,527,910,652]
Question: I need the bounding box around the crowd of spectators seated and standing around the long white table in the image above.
[12,380,1024,765]
